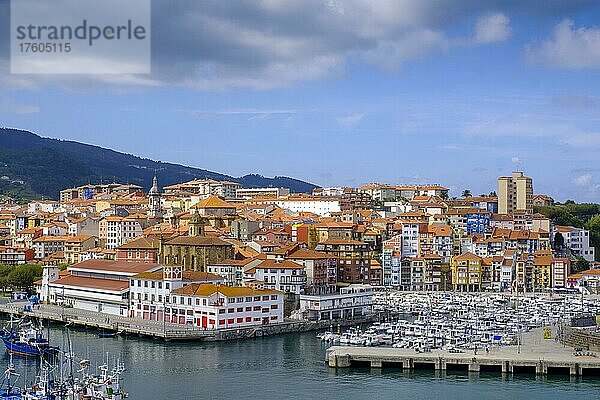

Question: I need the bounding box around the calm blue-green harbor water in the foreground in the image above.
[2,328,600,400]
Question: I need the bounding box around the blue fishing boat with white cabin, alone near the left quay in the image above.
[0,321,59,357]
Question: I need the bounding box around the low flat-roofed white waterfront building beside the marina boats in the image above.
[299,285,373,320]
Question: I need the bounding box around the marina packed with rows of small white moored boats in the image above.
[317,292,600,354]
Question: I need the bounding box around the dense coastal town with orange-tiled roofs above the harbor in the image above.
[0,172,600,331]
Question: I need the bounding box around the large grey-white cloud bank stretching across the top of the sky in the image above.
[0,0,528,90]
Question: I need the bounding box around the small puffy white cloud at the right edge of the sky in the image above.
[526,19,600,69]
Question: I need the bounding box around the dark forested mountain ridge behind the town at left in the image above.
[0,128,317,199]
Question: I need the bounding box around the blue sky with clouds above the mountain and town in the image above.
[0,0,600,202]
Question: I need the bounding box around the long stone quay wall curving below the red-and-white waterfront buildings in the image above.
[0,302,378,341]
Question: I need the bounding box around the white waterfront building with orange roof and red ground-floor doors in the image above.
[166,283,283,329]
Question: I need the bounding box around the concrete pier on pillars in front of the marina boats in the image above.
[325,329,600,376]
